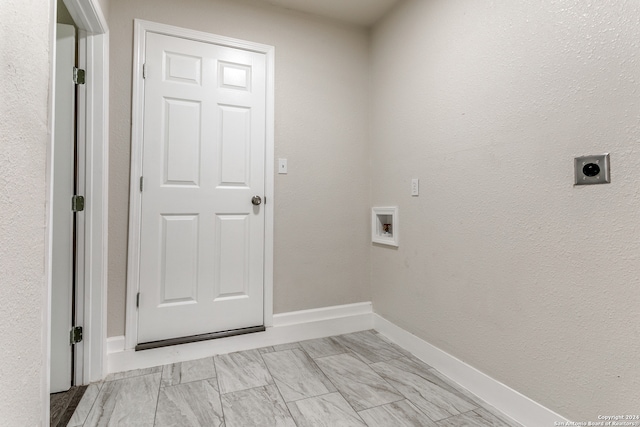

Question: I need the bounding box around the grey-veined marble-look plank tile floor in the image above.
[68,331,520,427]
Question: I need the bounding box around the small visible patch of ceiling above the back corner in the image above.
[254,0,399,26]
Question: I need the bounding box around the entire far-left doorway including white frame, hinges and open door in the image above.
[43,0,108,425]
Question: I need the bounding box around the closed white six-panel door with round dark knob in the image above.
[138,32,266,343]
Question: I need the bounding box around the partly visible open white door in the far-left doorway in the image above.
[50,16,78,393]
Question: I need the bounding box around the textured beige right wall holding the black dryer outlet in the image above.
[371,0,640,421]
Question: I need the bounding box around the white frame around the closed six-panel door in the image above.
[125,19,275,350]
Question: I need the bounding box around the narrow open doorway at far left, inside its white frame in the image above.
[49,6,85,426]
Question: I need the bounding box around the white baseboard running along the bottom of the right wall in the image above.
[373,313,568,427]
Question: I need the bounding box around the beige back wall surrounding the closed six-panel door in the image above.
[108,0,369,336]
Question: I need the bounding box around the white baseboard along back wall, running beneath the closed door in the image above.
[107,302,373,373]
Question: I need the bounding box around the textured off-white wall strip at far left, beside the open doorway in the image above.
[0,0,51,426]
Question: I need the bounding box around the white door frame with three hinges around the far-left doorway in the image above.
[45,0,109,389]
